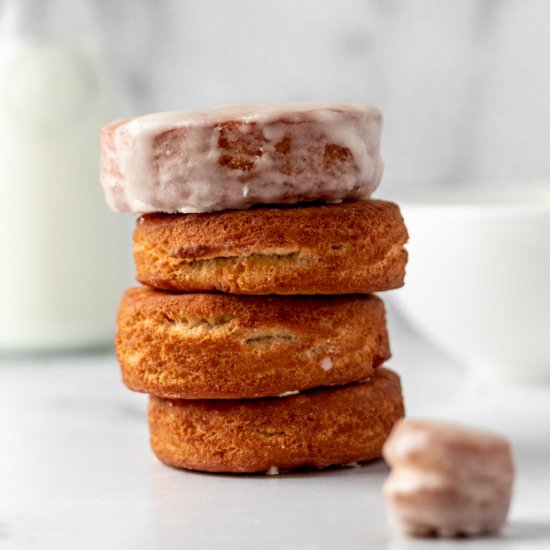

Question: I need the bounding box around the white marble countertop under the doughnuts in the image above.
[0,308,550,550]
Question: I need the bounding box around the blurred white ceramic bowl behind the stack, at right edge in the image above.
[394,183,550,381]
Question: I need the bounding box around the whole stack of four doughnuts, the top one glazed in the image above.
[101,104,407,473]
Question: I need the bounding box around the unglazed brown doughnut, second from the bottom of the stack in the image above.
[116,287,390,399]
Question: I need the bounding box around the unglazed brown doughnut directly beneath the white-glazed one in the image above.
[134,200,407,294]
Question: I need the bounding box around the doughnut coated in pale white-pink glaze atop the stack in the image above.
[100,103,383,213]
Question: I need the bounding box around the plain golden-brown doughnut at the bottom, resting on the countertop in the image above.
[149,368,403,473]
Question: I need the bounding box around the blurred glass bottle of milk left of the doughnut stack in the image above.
[0,0,129,354]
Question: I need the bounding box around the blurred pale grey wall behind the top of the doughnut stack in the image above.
[100,0,550,195]
